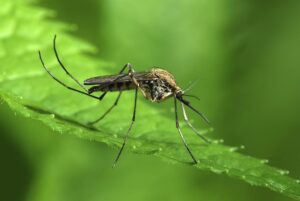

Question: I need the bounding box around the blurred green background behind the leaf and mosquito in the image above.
[0,0,300,201]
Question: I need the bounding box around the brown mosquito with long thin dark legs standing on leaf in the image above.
[38,35,210,167]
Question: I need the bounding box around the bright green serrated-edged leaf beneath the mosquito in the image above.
[0,0,300,200]
